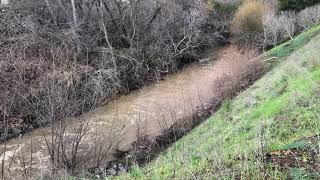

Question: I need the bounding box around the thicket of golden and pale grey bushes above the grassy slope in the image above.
[231,0,320,50]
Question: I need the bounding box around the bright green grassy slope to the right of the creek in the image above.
[117,26,320,179]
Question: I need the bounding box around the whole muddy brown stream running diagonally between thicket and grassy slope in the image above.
[0,47,262,179]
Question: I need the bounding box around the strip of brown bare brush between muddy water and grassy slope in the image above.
[90,49,265,178]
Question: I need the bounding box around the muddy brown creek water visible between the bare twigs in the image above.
[0,46,252,179]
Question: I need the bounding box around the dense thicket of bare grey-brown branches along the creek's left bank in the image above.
[0,0,230,140]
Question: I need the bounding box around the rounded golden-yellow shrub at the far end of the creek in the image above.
[232,0,265,33]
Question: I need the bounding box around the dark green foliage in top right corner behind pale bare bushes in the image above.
[278,0,320,11]
